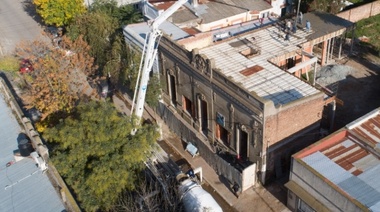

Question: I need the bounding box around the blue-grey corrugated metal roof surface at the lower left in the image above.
[0,94,65,212]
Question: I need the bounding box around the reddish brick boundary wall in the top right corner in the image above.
[337,1,380,22]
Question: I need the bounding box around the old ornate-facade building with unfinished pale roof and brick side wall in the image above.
[124,0,351,191]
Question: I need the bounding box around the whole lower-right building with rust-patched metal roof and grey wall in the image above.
[286,108,380,211]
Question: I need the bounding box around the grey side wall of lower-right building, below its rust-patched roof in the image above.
[289,159,362,211]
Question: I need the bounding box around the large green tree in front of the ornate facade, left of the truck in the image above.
[44,102,158,211]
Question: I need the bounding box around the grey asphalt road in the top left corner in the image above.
[0,0,48,56]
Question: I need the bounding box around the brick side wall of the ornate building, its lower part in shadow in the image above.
[263,93,323,181]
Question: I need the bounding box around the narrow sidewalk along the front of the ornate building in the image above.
[113,95,289,212]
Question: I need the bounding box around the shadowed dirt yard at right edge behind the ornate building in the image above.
[334,44,380,130]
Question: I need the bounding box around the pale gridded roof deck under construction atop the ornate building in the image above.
[199,26,319,105]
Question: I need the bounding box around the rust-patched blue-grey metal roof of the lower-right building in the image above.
[294,109,380,211]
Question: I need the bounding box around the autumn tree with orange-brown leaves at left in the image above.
[16,36,96,119]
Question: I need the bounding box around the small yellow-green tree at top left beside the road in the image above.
[33,0,86,26]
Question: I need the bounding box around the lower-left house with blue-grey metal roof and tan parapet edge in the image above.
[0,74,80,212]
